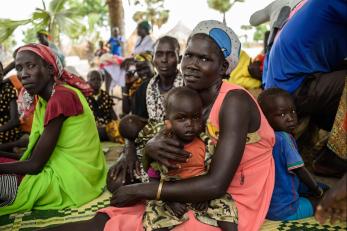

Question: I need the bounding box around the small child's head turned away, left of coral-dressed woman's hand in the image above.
[119,115,147,140]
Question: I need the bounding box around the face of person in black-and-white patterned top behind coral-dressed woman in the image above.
[153,42,179,77]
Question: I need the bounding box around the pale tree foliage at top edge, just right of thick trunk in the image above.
[133,0,170,28]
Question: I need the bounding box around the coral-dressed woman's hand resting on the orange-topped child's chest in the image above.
[145,132,191,169]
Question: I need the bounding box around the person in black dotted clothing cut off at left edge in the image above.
[0,62,21,146]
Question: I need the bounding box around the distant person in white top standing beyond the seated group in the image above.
[133,21,154,55]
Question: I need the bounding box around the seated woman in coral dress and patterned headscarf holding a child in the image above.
[51,20,274,231]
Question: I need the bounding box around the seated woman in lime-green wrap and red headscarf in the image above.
[0,44,107,216]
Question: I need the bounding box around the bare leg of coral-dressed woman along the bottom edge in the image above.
[40,213,110,231]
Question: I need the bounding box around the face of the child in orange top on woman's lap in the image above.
[167,95,202,143]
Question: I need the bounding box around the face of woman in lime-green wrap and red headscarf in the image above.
[15,51,53,95]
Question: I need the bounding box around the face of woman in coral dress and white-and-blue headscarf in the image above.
[181,36,226,90]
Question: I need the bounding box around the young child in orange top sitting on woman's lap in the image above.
[143,87,237,231]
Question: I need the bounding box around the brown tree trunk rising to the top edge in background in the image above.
[106,0,124,36]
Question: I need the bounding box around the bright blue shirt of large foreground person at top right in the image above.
[263,0,347,93]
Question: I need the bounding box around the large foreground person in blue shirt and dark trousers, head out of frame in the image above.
[263,0,347,176]
